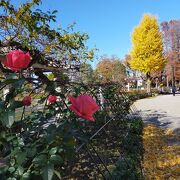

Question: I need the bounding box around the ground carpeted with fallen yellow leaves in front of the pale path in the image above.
[143,125,180,180]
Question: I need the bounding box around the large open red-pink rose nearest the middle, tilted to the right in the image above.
[69,95,99,121]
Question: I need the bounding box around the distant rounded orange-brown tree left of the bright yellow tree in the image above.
[96,57,126,82]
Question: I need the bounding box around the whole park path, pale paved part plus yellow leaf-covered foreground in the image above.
[134,94,180,179]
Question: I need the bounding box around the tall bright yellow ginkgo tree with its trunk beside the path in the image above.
[130,14,166,92]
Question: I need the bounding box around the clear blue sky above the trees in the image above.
[6,0,180,66]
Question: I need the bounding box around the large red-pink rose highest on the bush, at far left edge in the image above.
[2,50,31,72]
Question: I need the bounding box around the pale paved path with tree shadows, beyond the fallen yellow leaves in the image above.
[135,94,180,134]
